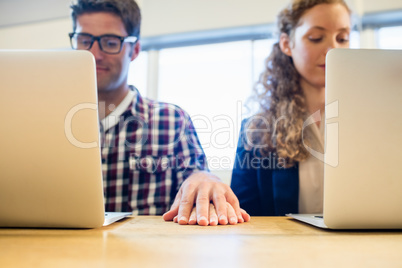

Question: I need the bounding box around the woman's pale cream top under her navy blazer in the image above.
[299,114,325,214]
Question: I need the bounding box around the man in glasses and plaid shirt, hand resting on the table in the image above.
[70,0,249,225]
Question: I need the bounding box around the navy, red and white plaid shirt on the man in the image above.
[101,87,208,215]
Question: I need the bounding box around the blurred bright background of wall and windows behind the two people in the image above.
[0,0,402,183]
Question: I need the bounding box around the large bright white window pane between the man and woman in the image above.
[158,41,254,170]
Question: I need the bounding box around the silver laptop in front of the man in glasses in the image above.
[0,50,131,228]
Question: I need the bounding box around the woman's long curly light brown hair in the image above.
[246,0,350,166]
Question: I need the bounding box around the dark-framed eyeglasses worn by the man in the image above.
[68,33,138,54]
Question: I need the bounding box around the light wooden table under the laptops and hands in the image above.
[0,216,402,268]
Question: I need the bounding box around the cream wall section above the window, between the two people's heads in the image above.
[143,0,286,36]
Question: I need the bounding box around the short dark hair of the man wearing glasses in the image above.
[70,0,141,38]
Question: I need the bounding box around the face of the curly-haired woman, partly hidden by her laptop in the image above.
[281,4,351,88]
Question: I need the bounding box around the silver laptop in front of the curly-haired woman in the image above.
[288,49,402,229]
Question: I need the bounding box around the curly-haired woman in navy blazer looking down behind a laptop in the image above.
[231,0,351,216]
